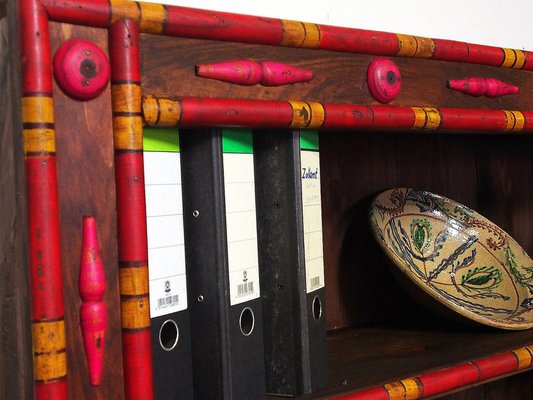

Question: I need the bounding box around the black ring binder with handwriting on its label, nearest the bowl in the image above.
[254,131,327,396]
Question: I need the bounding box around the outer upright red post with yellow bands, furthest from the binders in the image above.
[19,0,67,400]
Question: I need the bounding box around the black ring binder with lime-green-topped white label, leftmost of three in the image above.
[143,128,193,400]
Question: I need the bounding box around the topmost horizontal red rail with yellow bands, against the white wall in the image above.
[42,0,533,70]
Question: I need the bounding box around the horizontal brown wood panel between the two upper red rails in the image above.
[141,34,533,110]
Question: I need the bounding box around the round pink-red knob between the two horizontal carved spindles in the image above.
[367,58,402,104]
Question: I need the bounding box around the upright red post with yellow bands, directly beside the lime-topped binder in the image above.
[109,19,153,400]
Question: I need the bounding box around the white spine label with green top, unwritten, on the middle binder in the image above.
[222,131,260,306]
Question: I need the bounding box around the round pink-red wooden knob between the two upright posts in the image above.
[54,38,109,100]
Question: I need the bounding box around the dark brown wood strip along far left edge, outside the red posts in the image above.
[0,1,33,400]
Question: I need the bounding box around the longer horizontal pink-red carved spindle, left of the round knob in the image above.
[196,60,313,86]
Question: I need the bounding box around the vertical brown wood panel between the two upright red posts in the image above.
[50,23,124,399]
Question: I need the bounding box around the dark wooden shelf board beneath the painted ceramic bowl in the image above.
[296,322,533,399]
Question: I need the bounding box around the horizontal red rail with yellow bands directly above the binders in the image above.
[143,96,533,133]
